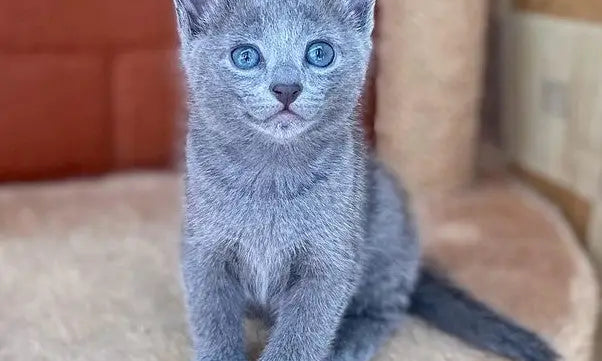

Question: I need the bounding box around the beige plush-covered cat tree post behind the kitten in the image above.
[375,0,488,193]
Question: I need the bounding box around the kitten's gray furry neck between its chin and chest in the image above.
[186,121,357,199]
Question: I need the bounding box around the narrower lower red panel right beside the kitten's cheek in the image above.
[112,51,183,168]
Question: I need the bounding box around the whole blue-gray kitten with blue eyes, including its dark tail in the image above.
[175,0,556,361]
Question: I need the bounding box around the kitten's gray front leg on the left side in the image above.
[182,240,246,361]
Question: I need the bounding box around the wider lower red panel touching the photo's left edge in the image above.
[0,55,111,180]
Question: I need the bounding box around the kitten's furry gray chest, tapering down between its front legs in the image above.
[186,154,361,300]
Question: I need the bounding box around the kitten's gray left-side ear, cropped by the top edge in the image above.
[173,0,217,43]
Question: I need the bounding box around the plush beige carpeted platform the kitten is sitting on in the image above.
[0,174,597,361]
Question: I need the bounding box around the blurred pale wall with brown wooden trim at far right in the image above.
[503,0,602,270]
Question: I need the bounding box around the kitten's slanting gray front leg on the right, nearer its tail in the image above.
[259,246,358,361]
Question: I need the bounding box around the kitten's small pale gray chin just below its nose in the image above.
[251,111,315,144]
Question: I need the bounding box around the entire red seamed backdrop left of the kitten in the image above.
[0,0,181,180]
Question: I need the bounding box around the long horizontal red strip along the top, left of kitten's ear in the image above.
[0,0,176,49]
